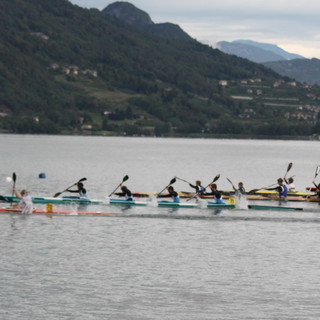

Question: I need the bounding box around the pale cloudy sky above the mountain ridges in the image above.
[69,0,320,59]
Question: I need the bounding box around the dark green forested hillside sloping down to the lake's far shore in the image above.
[0,0,317,136]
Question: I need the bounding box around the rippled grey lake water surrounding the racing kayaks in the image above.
[0,135,320,320]
